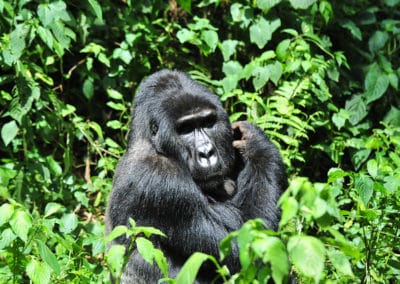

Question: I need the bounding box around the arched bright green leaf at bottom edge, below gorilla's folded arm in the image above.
[176,252,211,284]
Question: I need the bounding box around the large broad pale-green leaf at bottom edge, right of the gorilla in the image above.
[287,236,325,283]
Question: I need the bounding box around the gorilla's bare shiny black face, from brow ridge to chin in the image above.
[175,106,234,191]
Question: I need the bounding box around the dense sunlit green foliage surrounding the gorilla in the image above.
[0,0,400,283]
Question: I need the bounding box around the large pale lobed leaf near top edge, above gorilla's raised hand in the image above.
[249,17,281,49]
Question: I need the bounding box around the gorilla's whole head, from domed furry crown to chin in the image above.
[131,70,235,195]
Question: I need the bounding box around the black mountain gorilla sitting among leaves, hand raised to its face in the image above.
[106,70,287,284]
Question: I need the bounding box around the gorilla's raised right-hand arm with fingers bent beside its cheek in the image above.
[232,121,287,229]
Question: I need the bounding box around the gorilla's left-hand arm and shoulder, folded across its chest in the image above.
[107,141,243,257]
